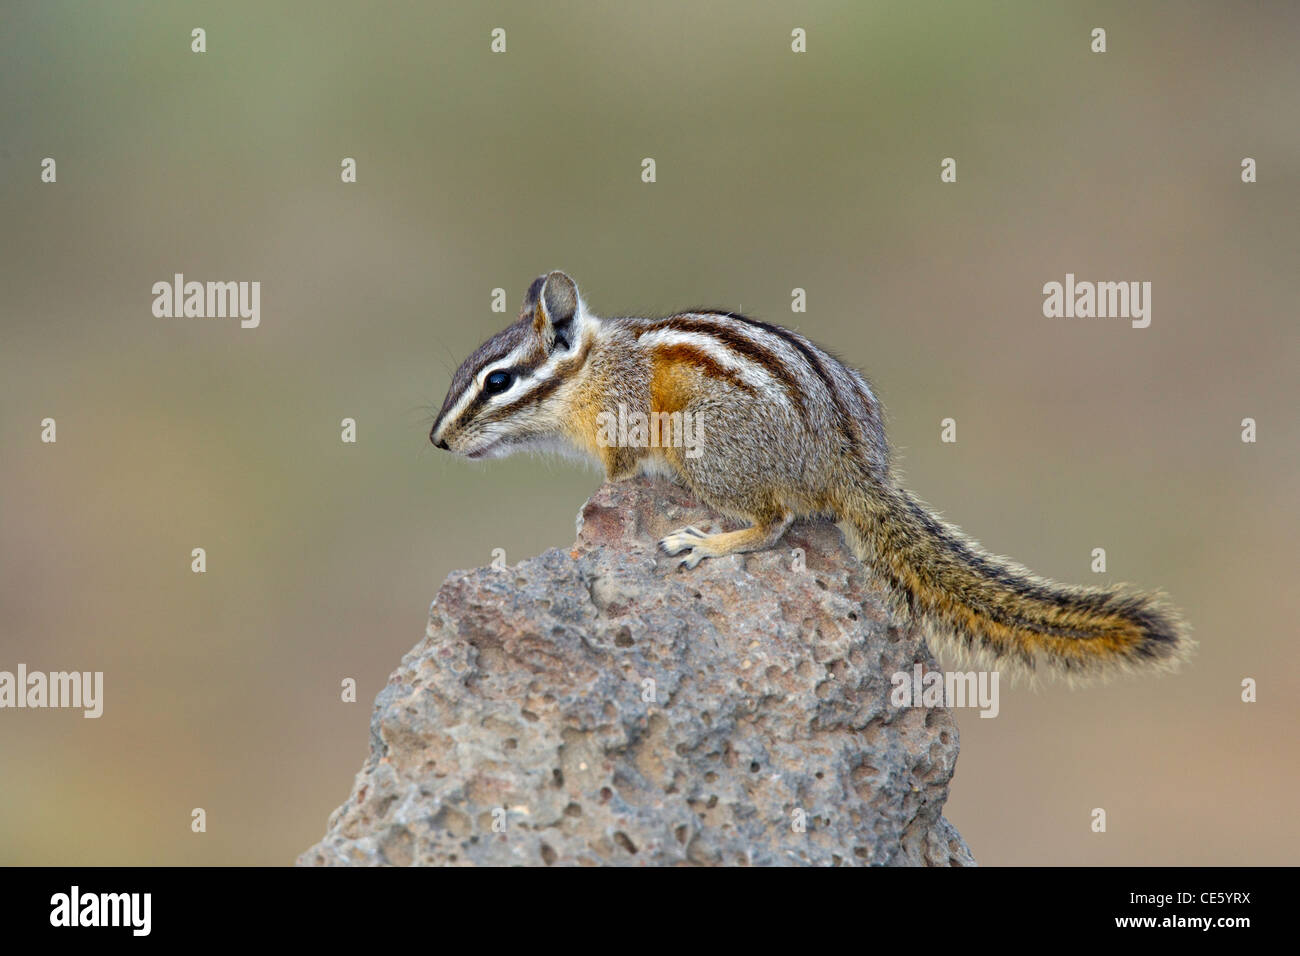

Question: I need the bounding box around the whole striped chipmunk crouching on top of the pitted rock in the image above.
[429,272,1191,678]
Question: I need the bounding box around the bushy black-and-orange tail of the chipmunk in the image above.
[840,485,1192,679]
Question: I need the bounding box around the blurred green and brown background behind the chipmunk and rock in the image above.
[0,3,1300,864]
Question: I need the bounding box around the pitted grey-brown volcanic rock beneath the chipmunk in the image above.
[298,479,974,866]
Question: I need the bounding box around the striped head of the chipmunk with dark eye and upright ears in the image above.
[429,272,594,458]
